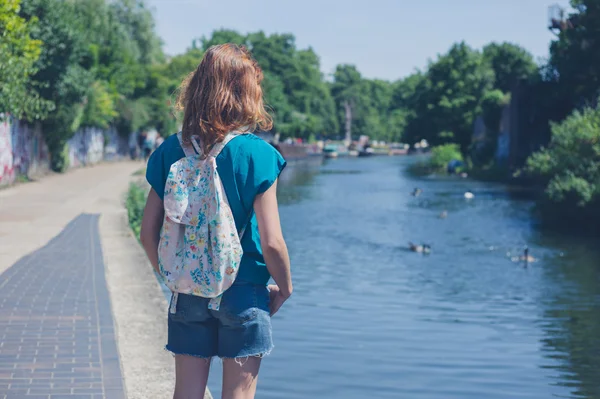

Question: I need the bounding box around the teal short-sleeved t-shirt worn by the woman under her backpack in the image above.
[146,134,286,285]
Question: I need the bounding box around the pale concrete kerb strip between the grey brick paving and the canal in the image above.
[100,177,212,399]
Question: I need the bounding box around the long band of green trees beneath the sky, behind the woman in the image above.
[0,0,584,188]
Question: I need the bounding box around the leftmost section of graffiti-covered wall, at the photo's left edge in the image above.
[0,117,49,185]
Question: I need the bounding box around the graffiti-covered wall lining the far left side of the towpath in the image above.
[0,115,129,186]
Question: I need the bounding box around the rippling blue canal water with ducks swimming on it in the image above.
[209,157,600,399]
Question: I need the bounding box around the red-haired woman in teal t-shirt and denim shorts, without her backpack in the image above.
[140,44,292,399]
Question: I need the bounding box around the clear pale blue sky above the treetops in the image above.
[147,0,568,80]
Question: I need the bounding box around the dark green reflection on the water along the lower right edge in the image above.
[539,235,600,398]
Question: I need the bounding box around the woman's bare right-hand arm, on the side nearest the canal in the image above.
[254,181,293,315]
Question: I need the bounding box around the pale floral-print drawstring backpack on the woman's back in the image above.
[158,132,245,313]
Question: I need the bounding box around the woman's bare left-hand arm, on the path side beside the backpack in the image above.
[140,189,165,273]
